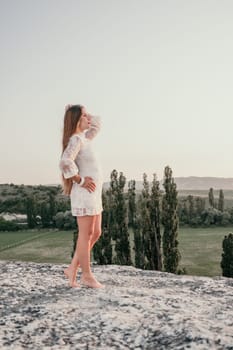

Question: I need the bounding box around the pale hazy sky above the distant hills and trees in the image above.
[0,0,233,185]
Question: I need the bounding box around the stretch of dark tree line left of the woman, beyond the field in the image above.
[0,184,71,231]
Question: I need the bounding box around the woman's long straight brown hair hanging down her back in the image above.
[62,105,82,195]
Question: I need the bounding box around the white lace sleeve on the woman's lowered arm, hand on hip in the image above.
[59,136,81,179]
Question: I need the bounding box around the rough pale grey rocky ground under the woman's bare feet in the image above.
[0,261,233,350]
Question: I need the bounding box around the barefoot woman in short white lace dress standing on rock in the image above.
[60,105,103,288]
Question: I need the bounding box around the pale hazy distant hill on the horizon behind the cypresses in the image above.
[104,176,233,191]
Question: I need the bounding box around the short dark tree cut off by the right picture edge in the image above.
[221,233,233,277]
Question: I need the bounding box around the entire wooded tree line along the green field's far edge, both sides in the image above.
[0,180,233,231]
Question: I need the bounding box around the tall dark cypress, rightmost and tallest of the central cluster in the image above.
[162,166,181,273]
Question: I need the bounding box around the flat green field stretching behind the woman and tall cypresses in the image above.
[0,227,233,276]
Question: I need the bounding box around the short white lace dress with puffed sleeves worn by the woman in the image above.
[60,116,103,216]
